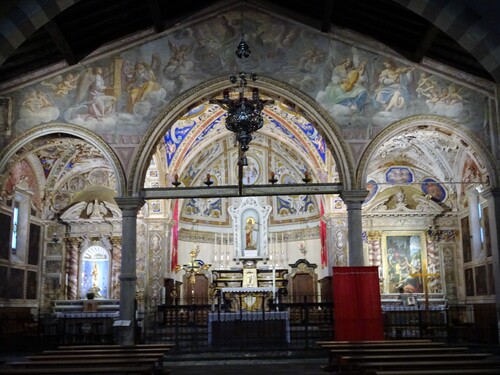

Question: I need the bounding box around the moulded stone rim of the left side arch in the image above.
[0,123,126,196]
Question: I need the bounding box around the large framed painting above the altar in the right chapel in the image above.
[382,231,427,293]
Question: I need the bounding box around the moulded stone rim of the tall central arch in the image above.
[128,76,354,196]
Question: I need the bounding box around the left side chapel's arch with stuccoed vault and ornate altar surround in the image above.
[0,123,126,309]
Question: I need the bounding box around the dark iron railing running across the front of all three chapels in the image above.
[0,299,499,352]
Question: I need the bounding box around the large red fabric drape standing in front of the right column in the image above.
[332,267,384,341]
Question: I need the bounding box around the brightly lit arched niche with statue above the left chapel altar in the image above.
[79,245,111,299]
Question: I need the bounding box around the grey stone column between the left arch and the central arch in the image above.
[115,197,144,345]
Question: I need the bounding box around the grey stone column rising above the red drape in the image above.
[340,190,368,266]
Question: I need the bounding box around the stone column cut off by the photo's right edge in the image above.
[482,188,500,337]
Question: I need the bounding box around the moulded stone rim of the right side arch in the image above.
[356,116,499,188]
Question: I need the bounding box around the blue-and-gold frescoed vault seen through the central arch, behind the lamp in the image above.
[146,97,335,226]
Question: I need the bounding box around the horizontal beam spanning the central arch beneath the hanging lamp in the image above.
[140,183,342,200]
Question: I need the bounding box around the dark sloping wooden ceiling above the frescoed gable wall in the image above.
[0,0,494,83]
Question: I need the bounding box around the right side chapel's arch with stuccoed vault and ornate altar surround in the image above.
[357,116,498,302]
